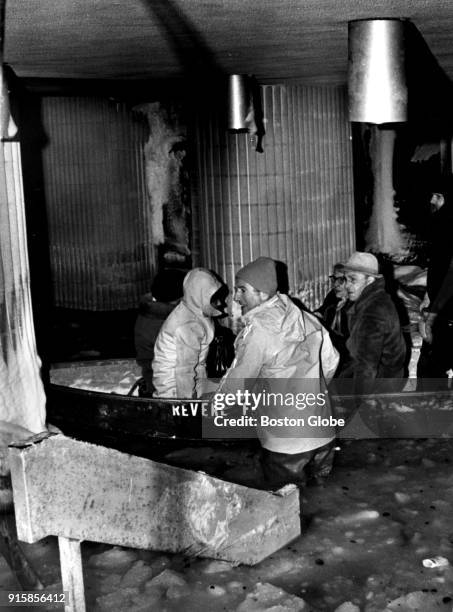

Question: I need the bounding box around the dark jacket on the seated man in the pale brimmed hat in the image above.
[340,278,406,393]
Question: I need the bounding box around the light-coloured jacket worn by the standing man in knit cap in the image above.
[217,294,339,454]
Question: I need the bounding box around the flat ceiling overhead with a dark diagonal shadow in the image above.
[4,0,453,84]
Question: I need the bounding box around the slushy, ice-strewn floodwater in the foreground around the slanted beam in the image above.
[0,439,453,612]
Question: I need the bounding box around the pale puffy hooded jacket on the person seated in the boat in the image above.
[152,268,222,398]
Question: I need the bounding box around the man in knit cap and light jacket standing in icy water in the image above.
[215,257,338,488]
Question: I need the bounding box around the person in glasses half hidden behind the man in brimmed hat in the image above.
[313,263,351,371]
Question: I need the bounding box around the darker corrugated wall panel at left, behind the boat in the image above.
[42,97,150,310]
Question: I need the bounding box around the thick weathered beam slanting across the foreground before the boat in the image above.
[9,435,300,565]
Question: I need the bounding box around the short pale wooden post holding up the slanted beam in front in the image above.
[58,537,86,612]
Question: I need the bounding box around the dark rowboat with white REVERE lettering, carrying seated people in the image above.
[47,360,453,458]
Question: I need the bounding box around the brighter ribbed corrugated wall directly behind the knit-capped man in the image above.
[193,86,355,307]
